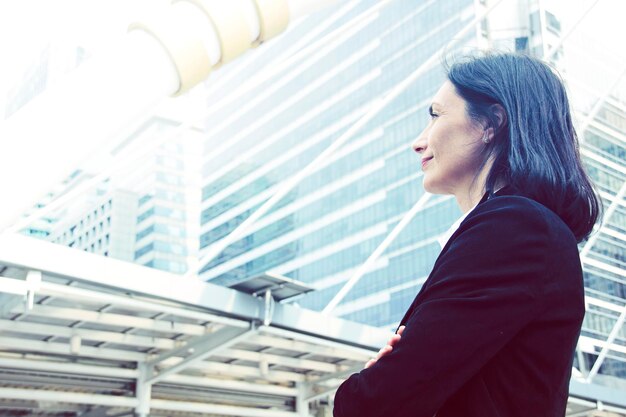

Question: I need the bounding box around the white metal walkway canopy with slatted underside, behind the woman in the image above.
[0,235,626,417]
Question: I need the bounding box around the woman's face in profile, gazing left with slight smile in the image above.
[412,81,485,197]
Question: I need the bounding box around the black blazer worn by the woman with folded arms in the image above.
[333,187,585,417]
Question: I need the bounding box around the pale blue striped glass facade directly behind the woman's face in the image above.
[200,0,477,326]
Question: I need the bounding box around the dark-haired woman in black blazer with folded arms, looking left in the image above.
[334,54,600,417]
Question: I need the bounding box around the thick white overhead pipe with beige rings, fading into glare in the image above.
[0,0,338,230]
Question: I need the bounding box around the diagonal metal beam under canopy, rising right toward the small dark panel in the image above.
[147,325,257,384]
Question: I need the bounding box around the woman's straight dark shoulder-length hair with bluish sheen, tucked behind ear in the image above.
[447,52,601,242]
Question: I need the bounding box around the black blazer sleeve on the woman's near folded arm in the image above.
[334,197,548,417]
